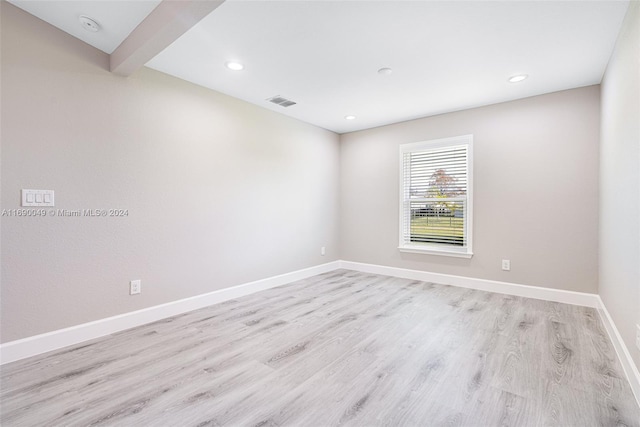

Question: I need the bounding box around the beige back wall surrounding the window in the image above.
[340,86,600,293]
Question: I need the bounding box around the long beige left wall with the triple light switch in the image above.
[0,2,339,342]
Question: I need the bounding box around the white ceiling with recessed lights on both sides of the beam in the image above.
[10,0,628,133]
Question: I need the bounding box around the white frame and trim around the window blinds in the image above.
[398,134,473,258]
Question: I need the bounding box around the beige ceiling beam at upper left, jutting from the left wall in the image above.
[110,0,224,77]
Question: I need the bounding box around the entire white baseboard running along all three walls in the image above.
[6,261,640,404]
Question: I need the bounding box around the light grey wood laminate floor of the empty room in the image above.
[0,270,640,427]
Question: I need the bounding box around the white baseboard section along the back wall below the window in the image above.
[340,261,600,308]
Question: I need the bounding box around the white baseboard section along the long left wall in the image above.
[0,261,340,365]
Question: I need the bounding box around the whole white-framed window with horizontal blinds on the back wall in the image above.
[399,135,473,258]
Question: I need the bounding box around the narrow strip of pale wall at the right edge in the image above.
[599,1,640,367]
